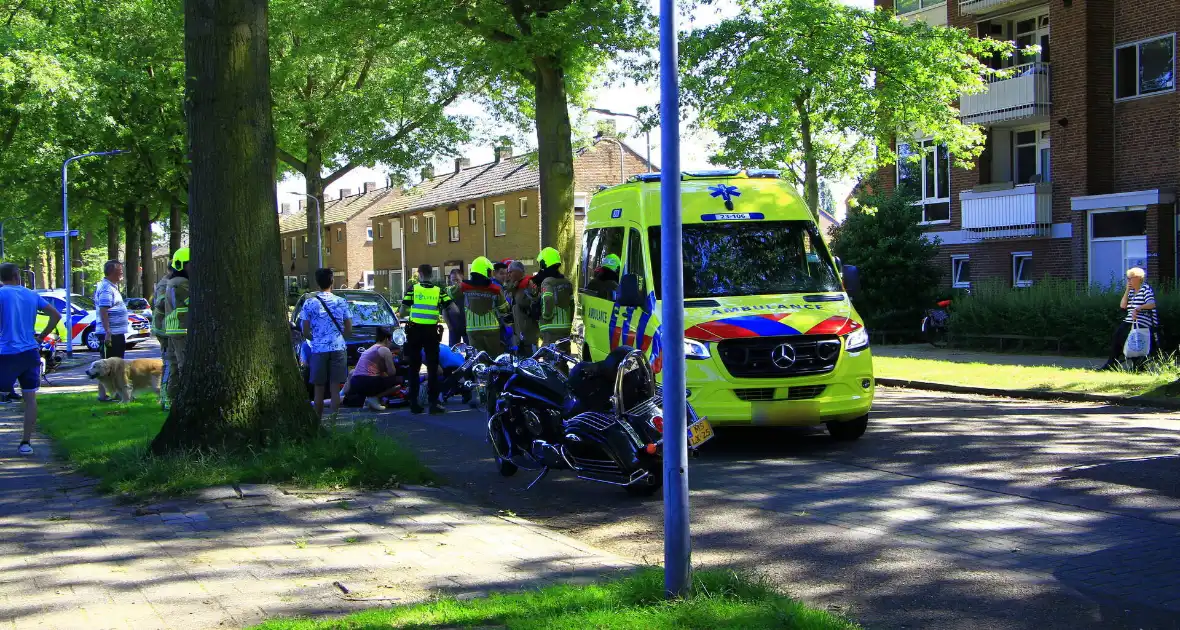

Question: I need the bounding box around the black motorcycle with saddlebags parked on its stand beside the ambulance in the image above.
[470,342,713,496]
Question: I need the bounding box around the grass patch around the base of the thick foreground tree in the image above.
[38,393,434,498]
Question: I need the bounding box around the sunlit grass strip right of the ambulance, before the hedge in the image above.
[873,356,1180,396]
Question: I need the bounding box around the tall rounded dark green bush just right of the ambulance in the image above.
[832,186,942,332]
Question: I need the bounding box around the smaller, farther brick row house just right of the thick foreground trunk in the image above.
[278,182,402,293]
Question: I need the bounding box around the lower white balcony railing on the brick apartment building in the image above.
[959,183,1053,241]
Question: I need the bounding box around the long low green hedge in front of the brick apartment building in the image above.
[950,278,1180,356]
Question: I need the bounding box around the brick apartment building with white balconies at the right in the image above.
[877,0,1180,288]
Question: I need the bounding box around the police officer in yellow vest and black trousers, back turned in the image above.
[401,263,451,414]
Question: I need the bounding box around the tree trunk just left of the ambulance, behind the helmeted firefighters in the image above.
[533,57,578,281]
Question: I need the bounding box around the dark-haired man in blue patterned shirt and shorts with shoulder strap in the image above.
[300,269,353,418]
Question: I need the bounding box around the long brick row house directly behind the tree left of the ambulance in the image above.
[372,136,648,297]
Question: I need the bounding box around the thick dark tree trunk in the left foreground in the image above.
[151,0,317,453]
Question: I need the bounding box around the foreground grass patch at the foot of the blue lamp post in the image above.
[253,569,859,630]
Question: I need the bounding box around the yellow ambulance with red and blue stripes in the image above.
[578,170,876,440]
